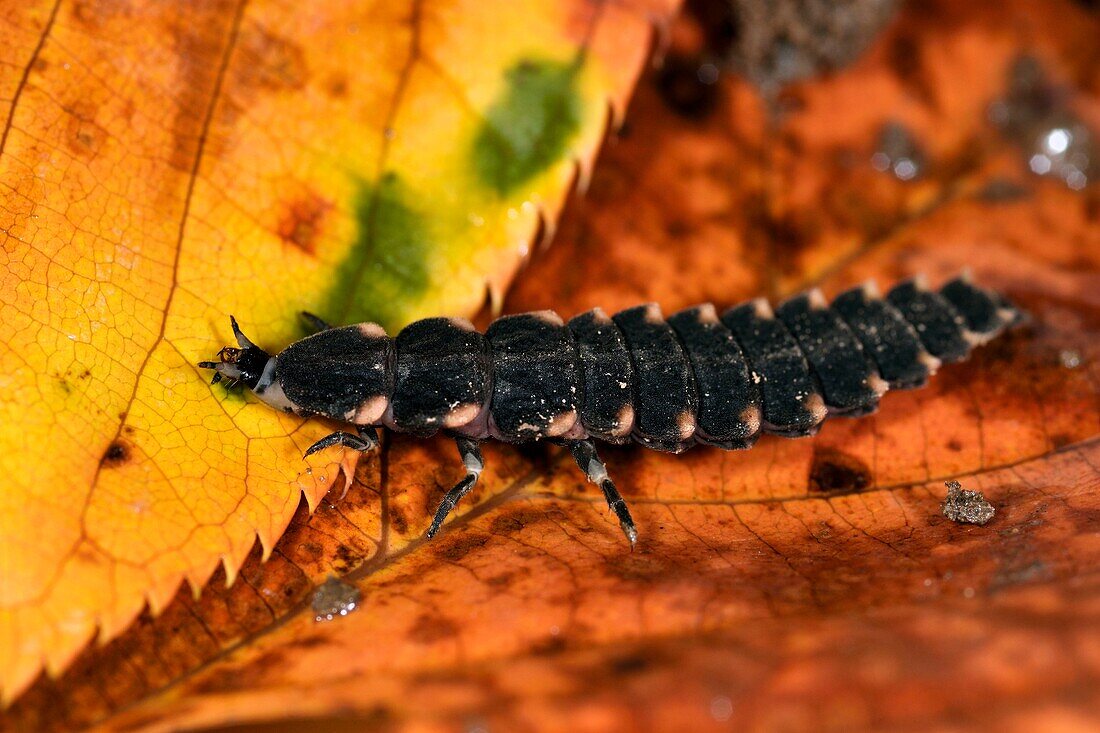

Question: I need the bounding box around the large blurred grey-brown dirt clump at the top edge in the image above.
[691,0,899,96]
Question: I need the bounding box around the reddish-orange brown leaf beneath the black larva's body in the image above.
[2,1,1100,731]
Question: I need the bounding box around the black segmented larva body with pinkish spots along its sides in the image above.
[266,272,1016,452]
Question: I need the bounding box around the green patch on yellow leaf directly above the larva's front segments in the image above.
[321,173,432,333]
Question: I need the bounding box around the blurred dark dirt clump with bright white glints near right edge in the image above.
[989,55,1100,190]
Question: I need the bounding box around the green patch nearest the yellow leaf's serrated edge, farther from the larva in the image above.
[473,59,583,196]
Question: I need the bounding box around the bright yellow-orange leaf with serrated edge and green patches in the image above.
[0,0,669,714]
